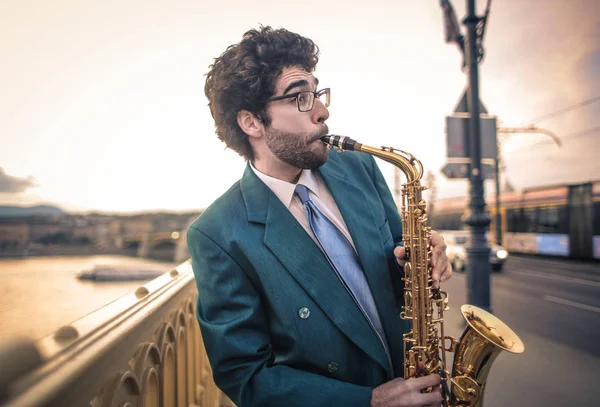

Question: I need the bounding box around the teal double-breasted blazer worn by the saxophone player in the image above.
[187,151,407,407]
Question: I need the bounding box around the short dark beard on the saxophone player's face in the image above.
[265,126,328,170]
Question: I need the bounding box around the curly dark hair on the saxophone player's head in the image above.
[204,25,319,160]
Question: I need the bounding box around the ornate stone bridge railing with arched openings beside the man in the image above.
[0,262,235,407]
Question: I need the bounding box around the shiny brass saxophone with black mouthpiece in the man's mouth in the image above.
[321,135,525,407]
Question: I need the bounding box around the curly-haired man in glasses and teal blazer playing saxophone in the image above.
[187,27,452,407]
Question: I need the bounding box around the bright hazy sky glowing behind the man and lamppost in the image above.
[0,0,600,212]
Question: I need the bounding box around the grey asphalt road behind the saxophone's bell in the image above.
[443,256,600,407]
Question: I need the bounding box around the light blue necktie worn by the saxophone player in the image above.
[296,184,389,355]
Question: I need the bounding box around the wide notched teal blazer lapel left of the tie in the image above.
[240,166,389,372]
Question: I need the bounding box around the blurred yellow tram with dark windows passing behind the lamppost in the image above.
[430,181,600,259]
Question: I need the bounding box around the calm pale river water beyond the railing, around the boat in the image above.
[0,255,176,339]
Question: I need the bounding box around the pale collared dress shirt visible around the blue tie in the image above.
[250,163,356,251]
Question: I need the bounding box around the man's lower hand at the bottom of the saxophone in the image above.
[371,374,442,407]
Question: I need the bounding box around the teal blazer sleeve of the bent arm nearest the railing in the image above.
[187,226,372,407]
